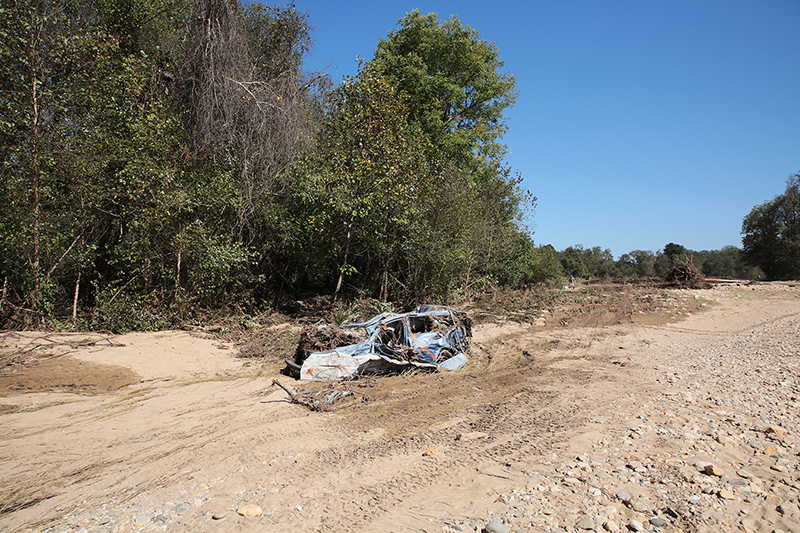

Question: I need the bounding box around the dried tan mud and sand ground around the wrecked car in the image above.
[0,284,800,532]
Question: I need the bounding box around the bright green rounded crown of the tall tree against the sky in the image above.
[370,10,517,165]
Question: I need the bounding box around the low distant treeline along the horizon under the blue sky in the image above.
[558,243,764,279]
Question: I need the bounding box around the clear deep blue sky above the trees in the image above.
[295,0,800,257]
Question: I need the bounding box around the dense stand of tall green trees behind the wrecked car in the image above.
[0,0,560,331]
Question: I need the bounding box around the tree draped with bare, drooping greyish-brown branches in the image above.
[177,0,318,244]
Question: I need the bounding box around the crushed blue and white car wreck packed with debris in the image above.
[286,305,472,381]
